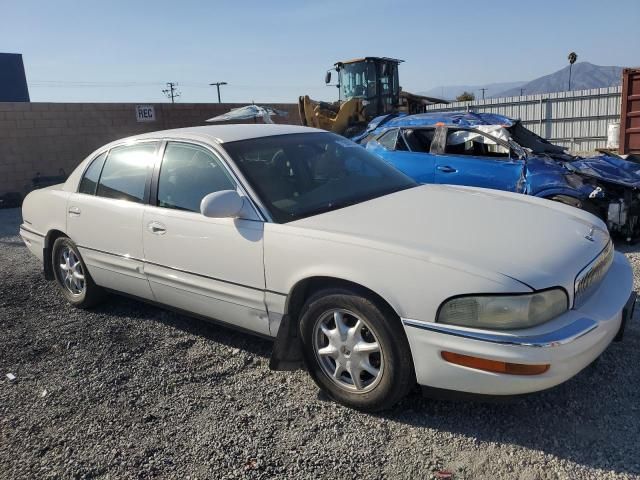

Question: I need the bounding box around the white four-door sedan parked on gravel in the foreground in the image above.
[20,125,635,410]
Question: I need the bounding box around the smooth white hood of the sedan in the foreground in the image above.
[289,185,609,291]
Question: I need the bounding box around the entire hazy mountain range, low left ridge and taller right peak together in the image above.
[417,62,622,100]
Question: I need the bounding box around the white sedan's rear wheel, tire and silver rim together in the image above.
[51,237,105,308]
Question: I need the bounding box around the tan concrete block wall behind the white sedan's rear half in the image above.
[0,102,300,195]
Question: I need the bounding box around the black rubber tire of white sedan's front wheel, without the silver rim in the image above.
[300,289,416,412]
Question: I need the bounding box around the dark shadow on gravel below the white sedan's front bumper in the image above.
[382,315,640,475]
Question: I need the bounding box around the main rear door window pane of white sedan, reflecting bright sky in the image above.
[97,142,157,203]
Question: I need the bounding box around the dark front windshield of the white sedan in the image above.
[224,132,417,223]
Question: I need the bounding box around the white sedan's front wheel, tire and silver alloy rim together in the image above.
[300,289,415,411]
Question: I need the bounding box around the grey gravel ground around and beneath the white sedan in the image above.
[0,210,640,480]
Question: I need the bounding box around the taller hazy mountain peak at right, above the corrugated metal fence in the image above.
[500,62,622,97]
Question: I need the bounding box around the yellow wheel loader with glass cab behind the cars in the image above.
[298,57,447,137]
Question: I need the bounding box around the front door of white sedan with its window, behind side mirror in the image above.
[142,142,269,335]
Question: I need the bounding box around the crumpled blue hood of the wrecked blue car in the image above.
[566,154,640,188]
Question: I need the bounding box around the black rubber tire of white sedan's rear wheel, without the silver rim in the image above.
[51,237,106,308]
